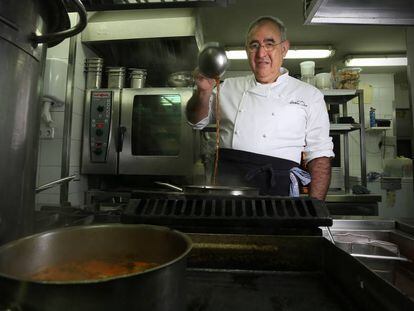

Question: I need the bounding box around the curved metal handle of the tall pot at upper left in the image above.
[32,0,87,44]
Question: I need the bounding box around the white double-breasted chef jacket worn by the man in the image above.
[193,68,334,163]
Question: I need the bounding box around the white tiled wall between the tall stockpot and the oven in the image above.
[36,14,96,207]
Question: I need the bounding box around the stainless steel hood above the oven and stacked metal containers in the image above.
[82,8,203,87]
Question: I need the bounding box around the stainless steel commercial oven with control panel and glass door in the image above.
[82,88,198,176]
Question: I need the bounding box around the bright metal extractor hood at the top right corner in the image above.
[303,0,414,25]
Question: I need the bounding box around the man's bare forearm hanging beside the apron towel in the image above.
[308,157,331,200]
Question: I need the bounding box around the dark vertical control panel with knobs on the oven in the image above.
[89,91,112,163]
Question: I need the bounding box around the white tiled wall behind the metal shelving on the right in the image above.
[340,74,395,177]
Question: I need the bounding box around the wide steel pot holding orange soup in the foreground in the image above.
[0,224,191,311]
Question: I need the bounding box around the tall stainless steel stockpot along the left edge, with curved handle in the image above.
[0,0,86,244]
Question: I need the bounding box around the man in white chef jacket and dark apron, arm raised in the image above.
[186,16,334,200]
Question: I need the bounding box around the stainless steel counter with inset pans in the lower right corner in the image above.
[322,219,414,300]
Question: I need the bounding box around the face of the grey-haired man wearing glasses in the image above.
[246,21,289,83]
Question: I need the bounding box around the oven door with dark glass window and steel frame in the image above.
[119,88,194,175]
